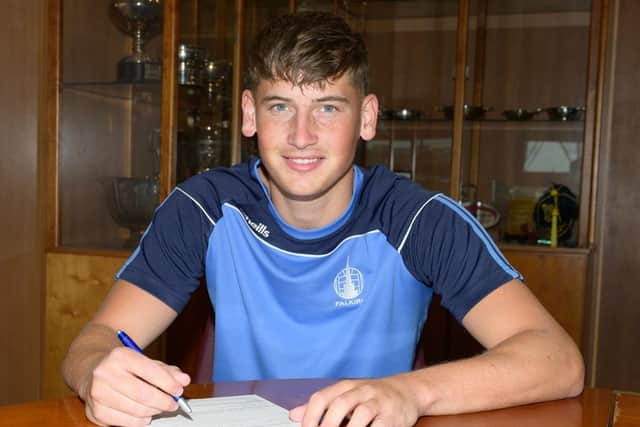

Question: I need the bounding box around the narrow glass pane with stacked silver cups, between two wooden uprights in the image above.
[176,0,236,182]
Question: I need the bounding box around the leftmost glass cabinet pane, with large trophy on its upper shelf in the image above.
[58,0,163,249]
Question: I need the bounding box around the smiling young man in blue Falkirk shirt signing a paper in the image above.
[63,13,583,427]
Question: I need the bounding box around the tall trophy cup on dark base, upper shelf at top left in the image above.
[111,0,162,83]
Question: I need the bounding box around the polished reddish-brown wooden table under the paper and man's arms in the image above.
[0,380,640,427]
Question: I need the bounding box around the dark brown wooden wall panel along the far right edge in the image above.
[594,0,640,391]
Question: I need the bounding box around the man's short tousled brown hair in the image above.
[245,12,368,94]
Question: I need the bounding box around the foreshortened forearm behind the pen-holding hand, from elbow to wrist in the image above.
[62,323,120,399]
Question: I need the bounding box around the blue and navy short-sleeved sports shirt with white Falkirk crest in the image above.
[118,159,520,381]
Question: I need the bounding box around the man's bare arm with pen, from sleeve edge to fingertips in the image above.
[62,280,185,426]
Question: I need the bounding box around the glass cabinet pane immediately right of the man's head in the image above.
[361,0,458,193]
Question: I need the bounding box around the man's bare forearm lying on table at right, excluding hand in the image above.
[406,331,584,415]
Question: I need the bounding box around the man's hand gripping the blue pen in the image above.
[78,347,190,427]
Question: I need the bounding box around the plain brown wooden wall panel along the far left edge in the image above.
[0,0,44,404]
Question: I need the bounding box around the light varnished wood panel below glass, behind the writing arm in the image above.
[43,253,125,399]
